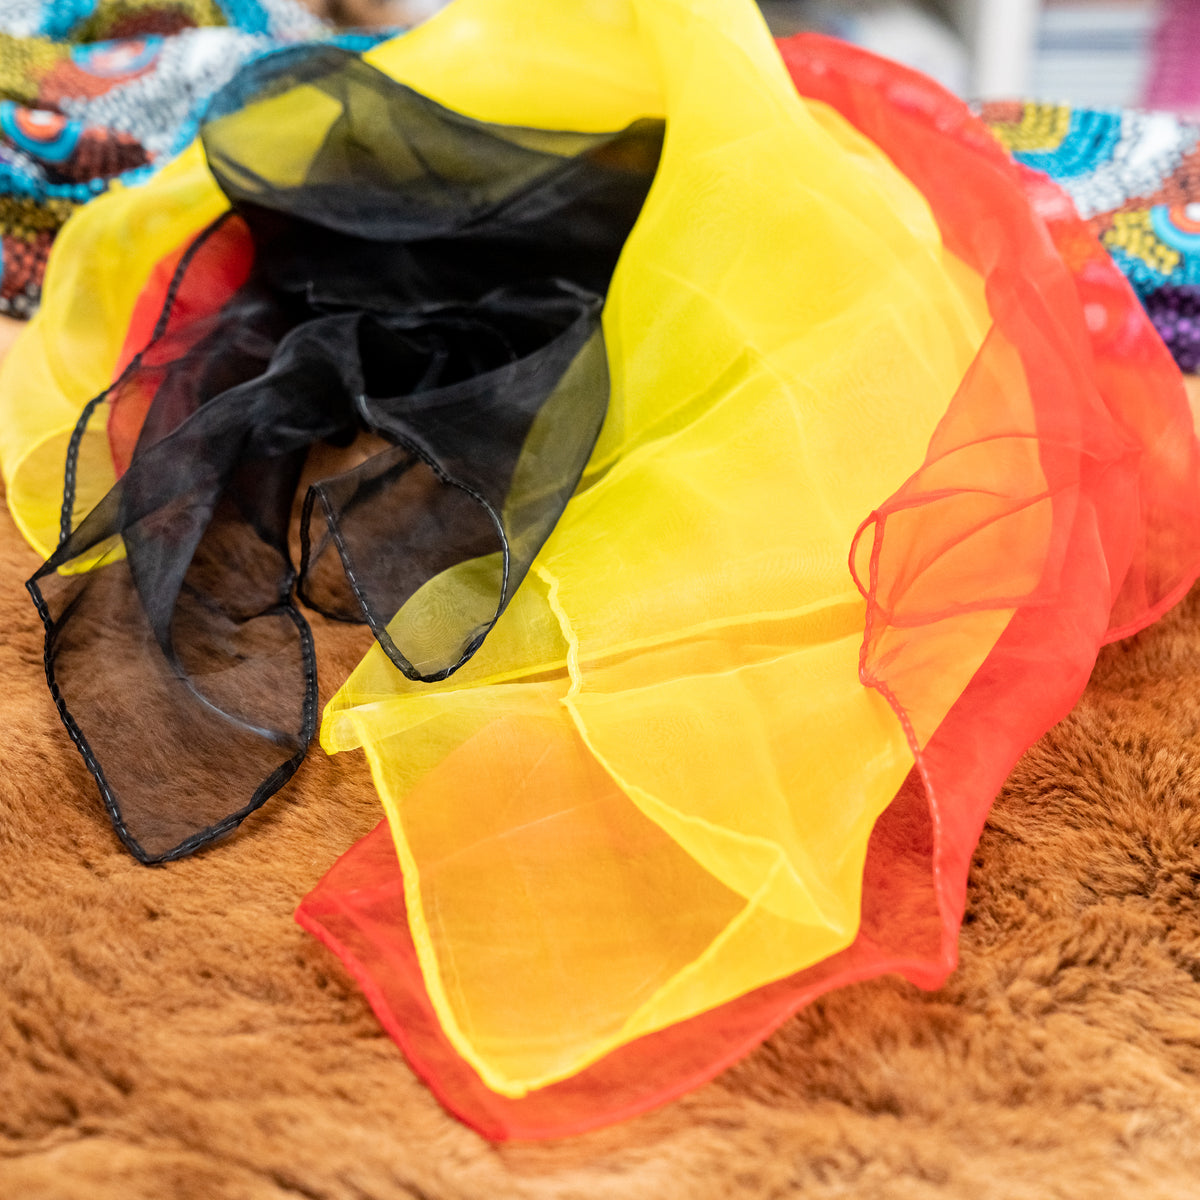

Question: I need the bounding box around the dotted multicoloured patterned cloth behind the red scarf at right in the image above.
[982,102,1200,372]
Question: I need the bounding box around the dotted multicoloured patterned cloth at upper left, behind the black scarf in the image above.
[0,0,326,317]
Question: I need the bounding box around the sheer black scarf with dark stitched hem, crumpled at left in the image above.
[29,47,662,862]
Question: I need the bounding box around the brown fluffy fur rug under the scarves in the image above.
[7,369,1200,1200]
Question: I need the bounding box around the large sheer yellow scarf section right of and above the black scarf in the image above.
[322,0,1012,1096]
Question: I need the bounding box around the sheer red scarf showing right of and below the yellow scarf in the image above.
[298,30,1200,1138]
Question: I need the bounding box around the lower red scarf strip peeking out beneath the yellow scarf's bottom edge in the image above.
[296,779,953,1141]
